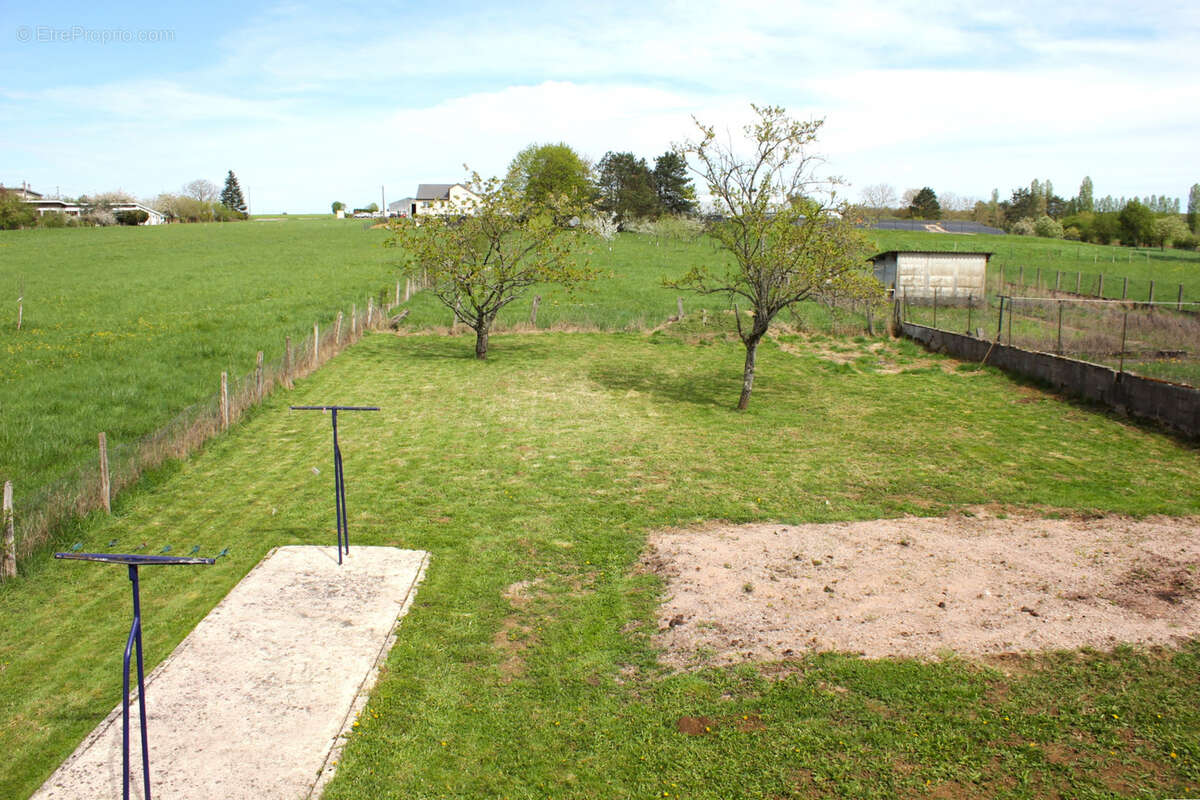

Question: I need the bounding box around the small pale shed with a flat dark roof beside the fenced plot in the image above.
[870,249,992,302]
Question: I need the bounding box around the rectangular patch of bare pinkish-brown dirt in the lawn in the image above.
[643,509,1200,668]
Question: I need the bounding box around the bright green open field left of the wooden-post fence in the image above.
[0,218,396,509]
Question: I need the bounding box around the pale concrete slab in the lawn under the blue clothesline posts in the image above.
[34,547,428,800]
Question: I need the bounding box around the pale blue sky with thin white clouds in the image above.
[0,0,1200,213]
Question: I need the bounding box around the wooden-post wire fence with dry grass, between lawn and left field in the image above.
[0,287,405,578]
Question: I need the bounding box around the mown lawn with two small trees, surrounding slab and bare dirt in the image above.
[0,328,1200,800]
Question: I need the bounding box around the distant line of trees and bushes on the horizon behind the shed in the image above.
[856,178,1200,249]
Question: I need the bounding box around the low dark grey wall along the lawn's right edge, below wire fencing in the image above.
[901,323,1200,438]
